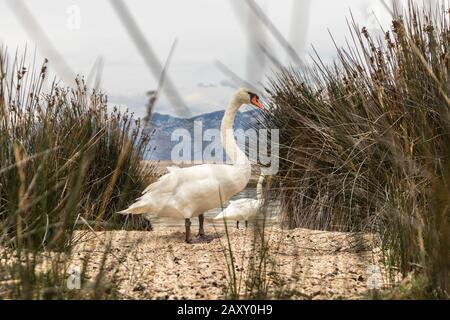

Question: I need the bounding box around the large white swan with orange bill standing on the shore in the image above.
[119,88,262,242]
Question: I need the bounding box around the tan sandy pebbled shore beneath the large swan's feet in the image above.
[72,226,384,299]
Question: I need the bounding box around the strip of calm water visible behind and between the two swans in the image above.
[151,188,277,228]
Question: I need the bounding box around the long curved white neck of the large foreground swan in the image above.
[220,97,250,168]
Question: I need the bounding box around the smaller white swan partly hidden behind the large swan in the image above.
[214,174,264,229]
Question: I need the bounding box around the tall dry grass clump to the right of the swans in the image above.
[267,6,450,298]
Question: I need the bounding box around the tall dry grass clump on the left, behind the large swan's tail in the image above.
[0,49,156,299]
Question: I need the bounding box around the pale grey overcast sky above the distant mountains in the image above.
[0,0,438,115]
